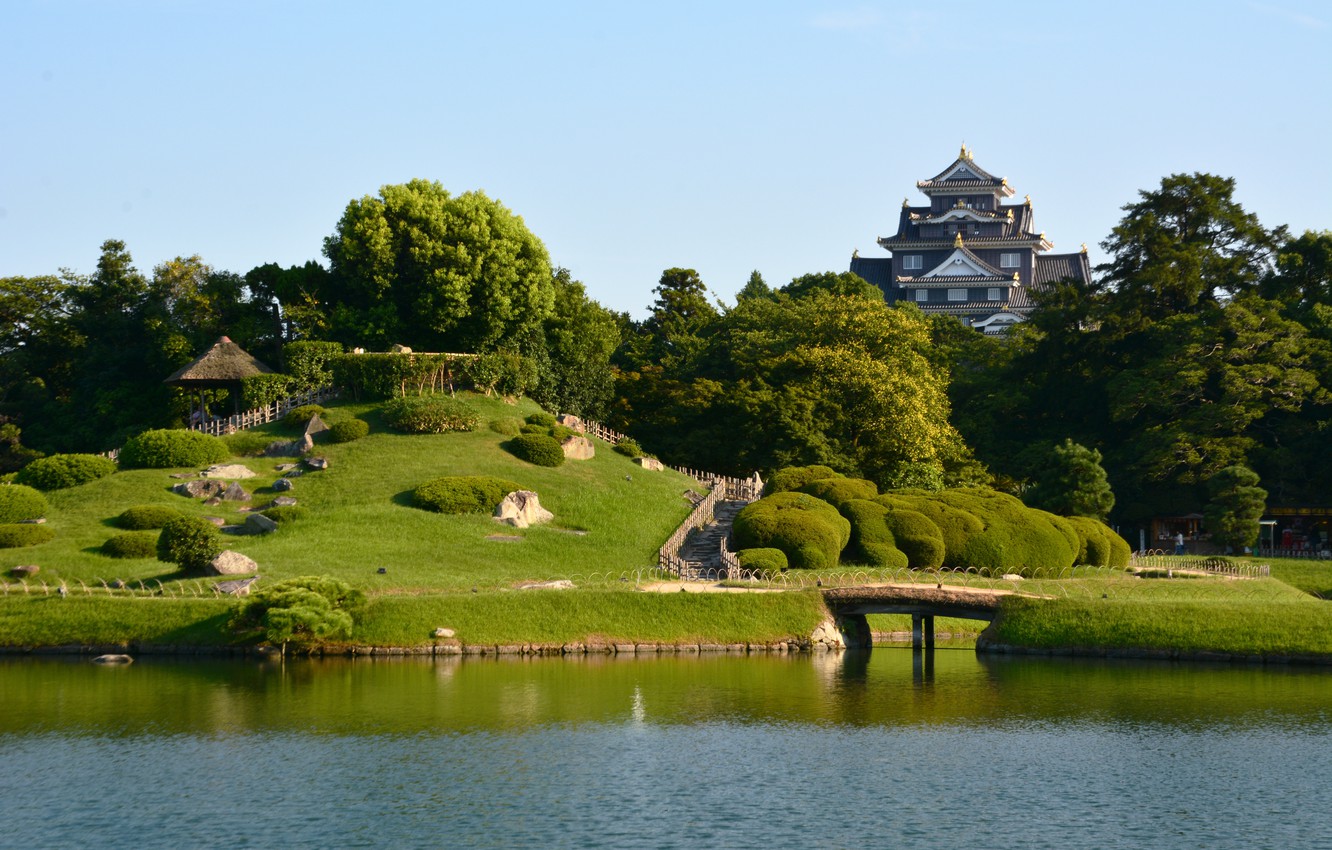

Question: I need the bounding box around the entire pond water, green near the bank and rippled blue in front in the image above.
[0,647,1332,850]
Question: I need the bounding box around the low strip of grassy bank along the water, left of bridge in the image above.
[0,589,826,646]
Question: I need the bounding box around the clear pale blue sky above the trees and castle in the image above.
[0,0,1332,316]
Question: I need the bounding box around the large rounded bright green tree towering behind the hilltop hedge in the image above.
[318,180,554,352]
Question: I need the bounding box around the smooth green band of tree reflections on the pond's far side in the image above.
[0,649,1332,735]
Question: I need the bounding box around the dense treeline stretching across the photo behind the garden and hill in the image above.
[0,175,1332,543]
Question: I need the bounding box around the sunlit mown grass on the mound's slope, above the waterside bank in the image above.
[0,397,698,592]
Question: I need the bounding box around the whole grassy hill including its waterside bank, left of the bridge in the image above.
[0,396,823,646]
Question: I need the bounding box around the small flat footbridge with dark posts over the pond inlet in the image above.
[823,585,1010,649]
